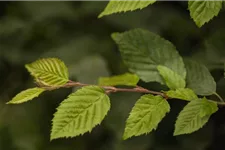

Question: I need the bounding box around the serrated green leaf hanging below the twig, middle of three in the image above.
[123,94,170,139]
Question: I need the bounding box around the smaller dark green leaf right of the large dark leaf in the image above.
[185,60,216,95]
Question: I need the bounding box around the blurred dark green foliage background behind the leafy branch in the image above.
[0,0,225,150]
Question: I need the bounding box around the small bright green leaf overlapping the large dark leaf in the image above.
[157,65,186,90]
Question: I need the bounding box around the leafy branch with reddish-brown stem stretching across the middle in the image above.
[8,29,224,139]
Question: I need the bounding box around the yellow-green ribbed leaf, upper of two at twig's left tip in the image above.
[26,58,69,86]
